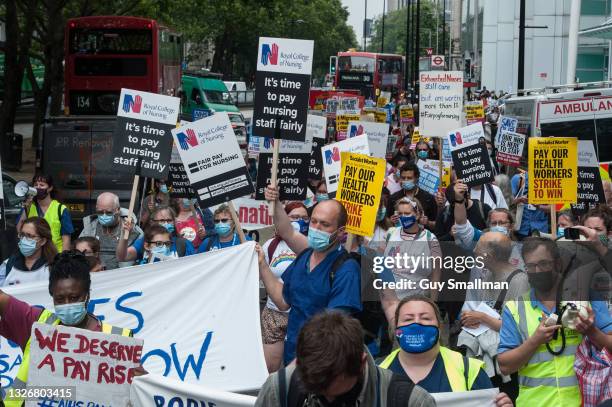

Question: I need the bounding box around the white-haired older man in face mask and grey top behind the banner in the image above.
[79,192,143,270]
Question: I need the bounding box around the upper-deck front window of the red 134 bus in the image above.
[68,28,153,55]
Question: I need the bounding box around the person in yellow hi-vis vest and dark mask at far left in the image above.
[17,174,74,252]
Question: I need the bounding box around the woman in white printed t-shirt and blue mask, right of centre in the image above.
[385,198,442,301]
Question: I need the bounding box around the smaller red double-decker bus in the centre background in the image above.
[334,51,404,100]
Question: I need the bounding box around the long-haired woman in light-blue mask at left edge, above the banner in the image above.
[0,217,57,286]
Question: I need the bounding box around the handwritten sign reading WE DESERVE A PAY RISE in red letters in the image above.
[26,322,143,407]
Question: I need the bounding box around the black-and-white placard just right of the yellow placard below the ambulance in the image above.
[572,140,606,214]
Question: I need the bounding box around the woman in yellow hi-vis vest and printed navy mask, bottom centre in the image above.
[380,295,513,407]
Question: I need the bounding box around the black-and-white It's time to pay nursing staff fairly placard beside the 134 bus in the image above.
[112,89,181,179]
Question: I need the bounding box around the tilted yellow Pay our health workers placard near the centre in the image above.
[336,152,386,236]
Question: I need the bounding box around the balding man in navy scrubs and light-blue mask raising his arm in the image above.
[257,185,361,364]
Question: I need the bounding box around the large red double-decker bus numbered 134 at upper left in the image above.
[64,16,183,115]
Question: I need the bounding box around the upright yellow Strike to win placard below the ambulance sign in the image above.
[528,137,578,205]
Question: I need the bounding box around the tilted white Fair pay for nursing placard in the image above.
[172,112,253,208]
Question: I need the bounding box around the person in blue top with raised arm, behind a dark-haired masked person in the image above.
[116,206,196,263]
